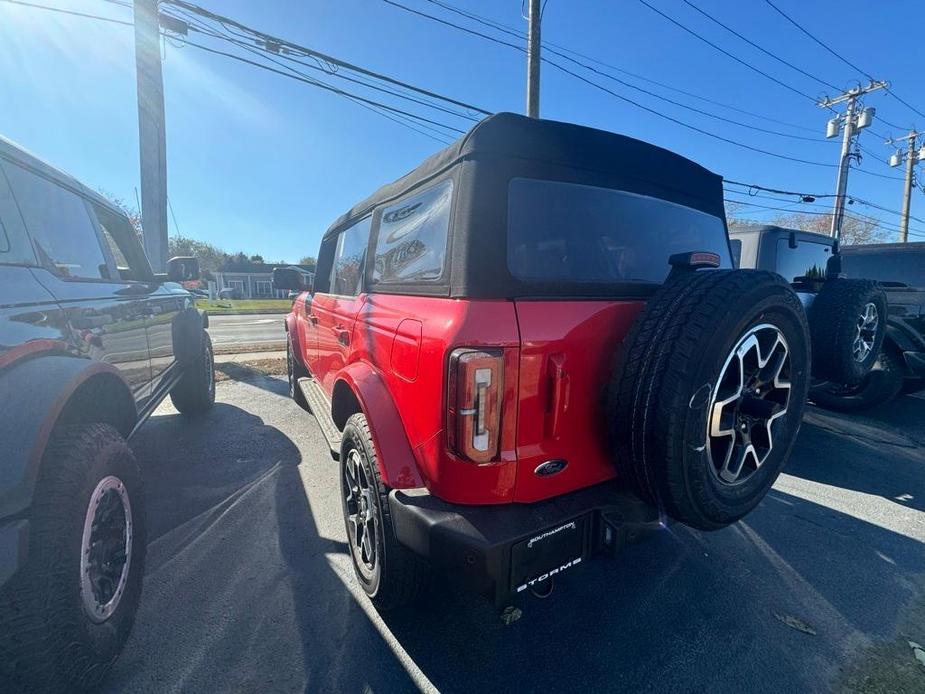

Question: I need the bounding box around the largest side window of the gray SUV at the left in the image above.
[4,162,110,279]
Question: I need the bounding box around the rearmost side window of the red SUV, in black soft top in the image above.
[373,181,453,284]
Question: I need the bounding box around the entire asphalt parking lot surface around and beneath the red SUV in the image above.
[107,377,925,693]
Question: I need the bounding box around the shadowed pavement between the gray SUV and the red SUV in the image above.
[107,400,414,692]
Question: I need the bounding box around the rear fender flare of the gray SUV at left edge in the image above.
[0,356,138,518]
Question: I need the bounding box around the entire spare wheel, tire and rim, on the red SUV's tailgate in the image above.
[608,269,809,530]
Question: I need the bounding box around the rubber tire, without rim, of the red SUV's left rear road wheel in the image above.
[340,413,429,611]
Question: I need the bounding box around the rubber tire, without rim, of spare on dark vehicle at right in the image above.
[809,278,887,385]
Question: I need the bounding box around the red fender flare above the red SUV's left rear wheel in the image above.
[335,362,424,489]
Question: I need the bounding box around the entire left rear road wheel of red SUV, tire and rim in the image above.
[340,413,428,612]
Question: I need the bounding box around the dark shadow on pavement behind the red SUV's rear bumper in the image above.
[384,491,925,693]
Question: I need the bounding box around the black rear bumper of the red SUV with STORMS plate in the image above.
[389,482,660,605]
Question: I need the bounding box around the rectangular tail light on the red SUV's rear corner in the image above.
[447,348,504,463]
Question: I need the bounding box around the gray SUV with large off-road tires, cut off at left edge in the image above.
[0,138,215,692]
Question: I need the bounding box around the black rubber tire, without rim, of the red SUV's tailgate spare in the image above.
[607,270,809,530]
